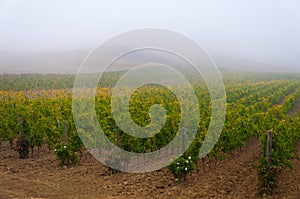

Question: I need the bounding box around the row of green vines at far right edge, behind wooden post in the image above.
[256,88,300,195]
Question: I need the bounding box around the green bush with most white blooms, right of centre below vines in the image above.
[167,156,194,182]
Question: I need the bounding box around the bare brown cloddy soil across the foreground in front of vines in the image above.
[0,140,300,199]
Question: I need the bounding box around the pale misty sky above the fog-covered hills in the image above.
[0,0,300,72]
